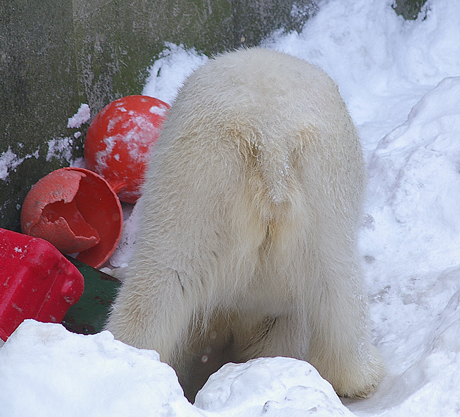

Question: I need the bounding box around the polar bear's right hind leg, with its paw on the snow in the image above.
[307,250,383,398]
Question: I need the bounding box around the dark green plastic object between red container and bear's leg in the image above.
[62,257,121,334]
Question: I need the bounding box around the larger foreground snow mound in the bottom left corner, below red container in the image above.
[0,320,196,417]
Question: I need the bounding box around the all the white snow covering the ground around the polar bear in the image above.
[0,0,460,417]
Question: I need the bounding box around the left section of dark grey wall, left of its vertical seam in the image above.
[0,0,81,230]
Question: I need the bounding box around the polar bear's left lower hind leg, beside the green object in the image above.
[105,261,196,364]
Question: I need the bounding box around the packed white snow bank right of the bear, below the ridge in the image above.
[349,77,460,416]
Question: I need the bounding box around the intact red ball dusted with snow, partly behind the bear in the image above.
[85,96,169,203]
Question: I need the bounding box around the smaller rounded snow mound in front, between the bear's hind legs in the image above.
[195,357,353,417]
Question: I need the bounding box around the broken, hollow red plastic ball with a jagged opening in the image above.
[21,168,123,268]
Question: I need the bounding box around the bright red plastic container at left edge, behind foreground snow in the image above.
[0,229,84,341]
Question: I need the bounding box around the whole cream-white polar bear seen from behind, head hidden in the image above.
[106,48,382,399]
